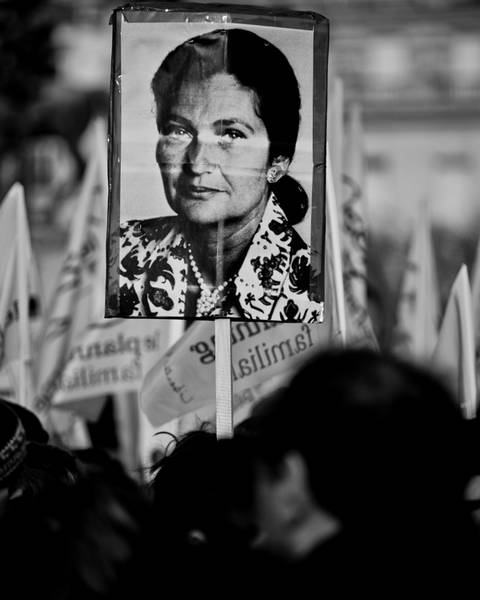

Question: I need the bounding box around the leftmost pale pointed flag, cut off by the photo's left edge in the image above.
[0,183,41,408]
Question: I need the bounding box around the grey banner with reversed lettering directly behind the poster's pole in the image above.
[140,322,330,426]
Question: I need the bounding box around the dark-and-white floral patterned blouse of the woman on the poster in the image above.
[119,195,323,323]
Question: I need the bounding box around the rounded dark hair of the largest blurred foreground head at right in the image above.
[257,350,470,522]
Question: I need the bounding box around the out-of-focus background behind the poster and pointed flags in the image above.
[0,0,480,348]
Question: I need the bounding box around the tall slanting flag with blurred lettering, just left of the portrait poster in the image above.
[34,120,107,445]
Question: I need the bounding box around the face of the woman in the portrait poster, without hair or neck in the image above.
[157,73,269,225]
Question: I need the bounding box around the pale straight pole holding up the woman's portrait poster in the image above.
[215,319,233,439]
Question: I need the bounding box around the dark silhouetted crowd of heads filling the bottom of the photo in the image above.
[0,349,480,599]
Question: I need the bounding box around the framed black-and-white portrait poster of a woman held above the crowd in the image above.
[105,3,328,323]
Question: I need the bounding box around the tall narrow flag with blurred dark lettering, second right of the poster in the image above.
[341,104,378,350]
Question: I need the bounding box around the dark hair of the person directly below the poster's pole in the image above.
[151,427,256,549]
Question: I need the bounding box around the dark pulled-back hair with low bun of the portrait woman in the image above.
[152,29,308,224]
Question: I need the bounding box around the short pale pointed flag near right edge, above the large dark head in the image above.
[432,265,476,419]
